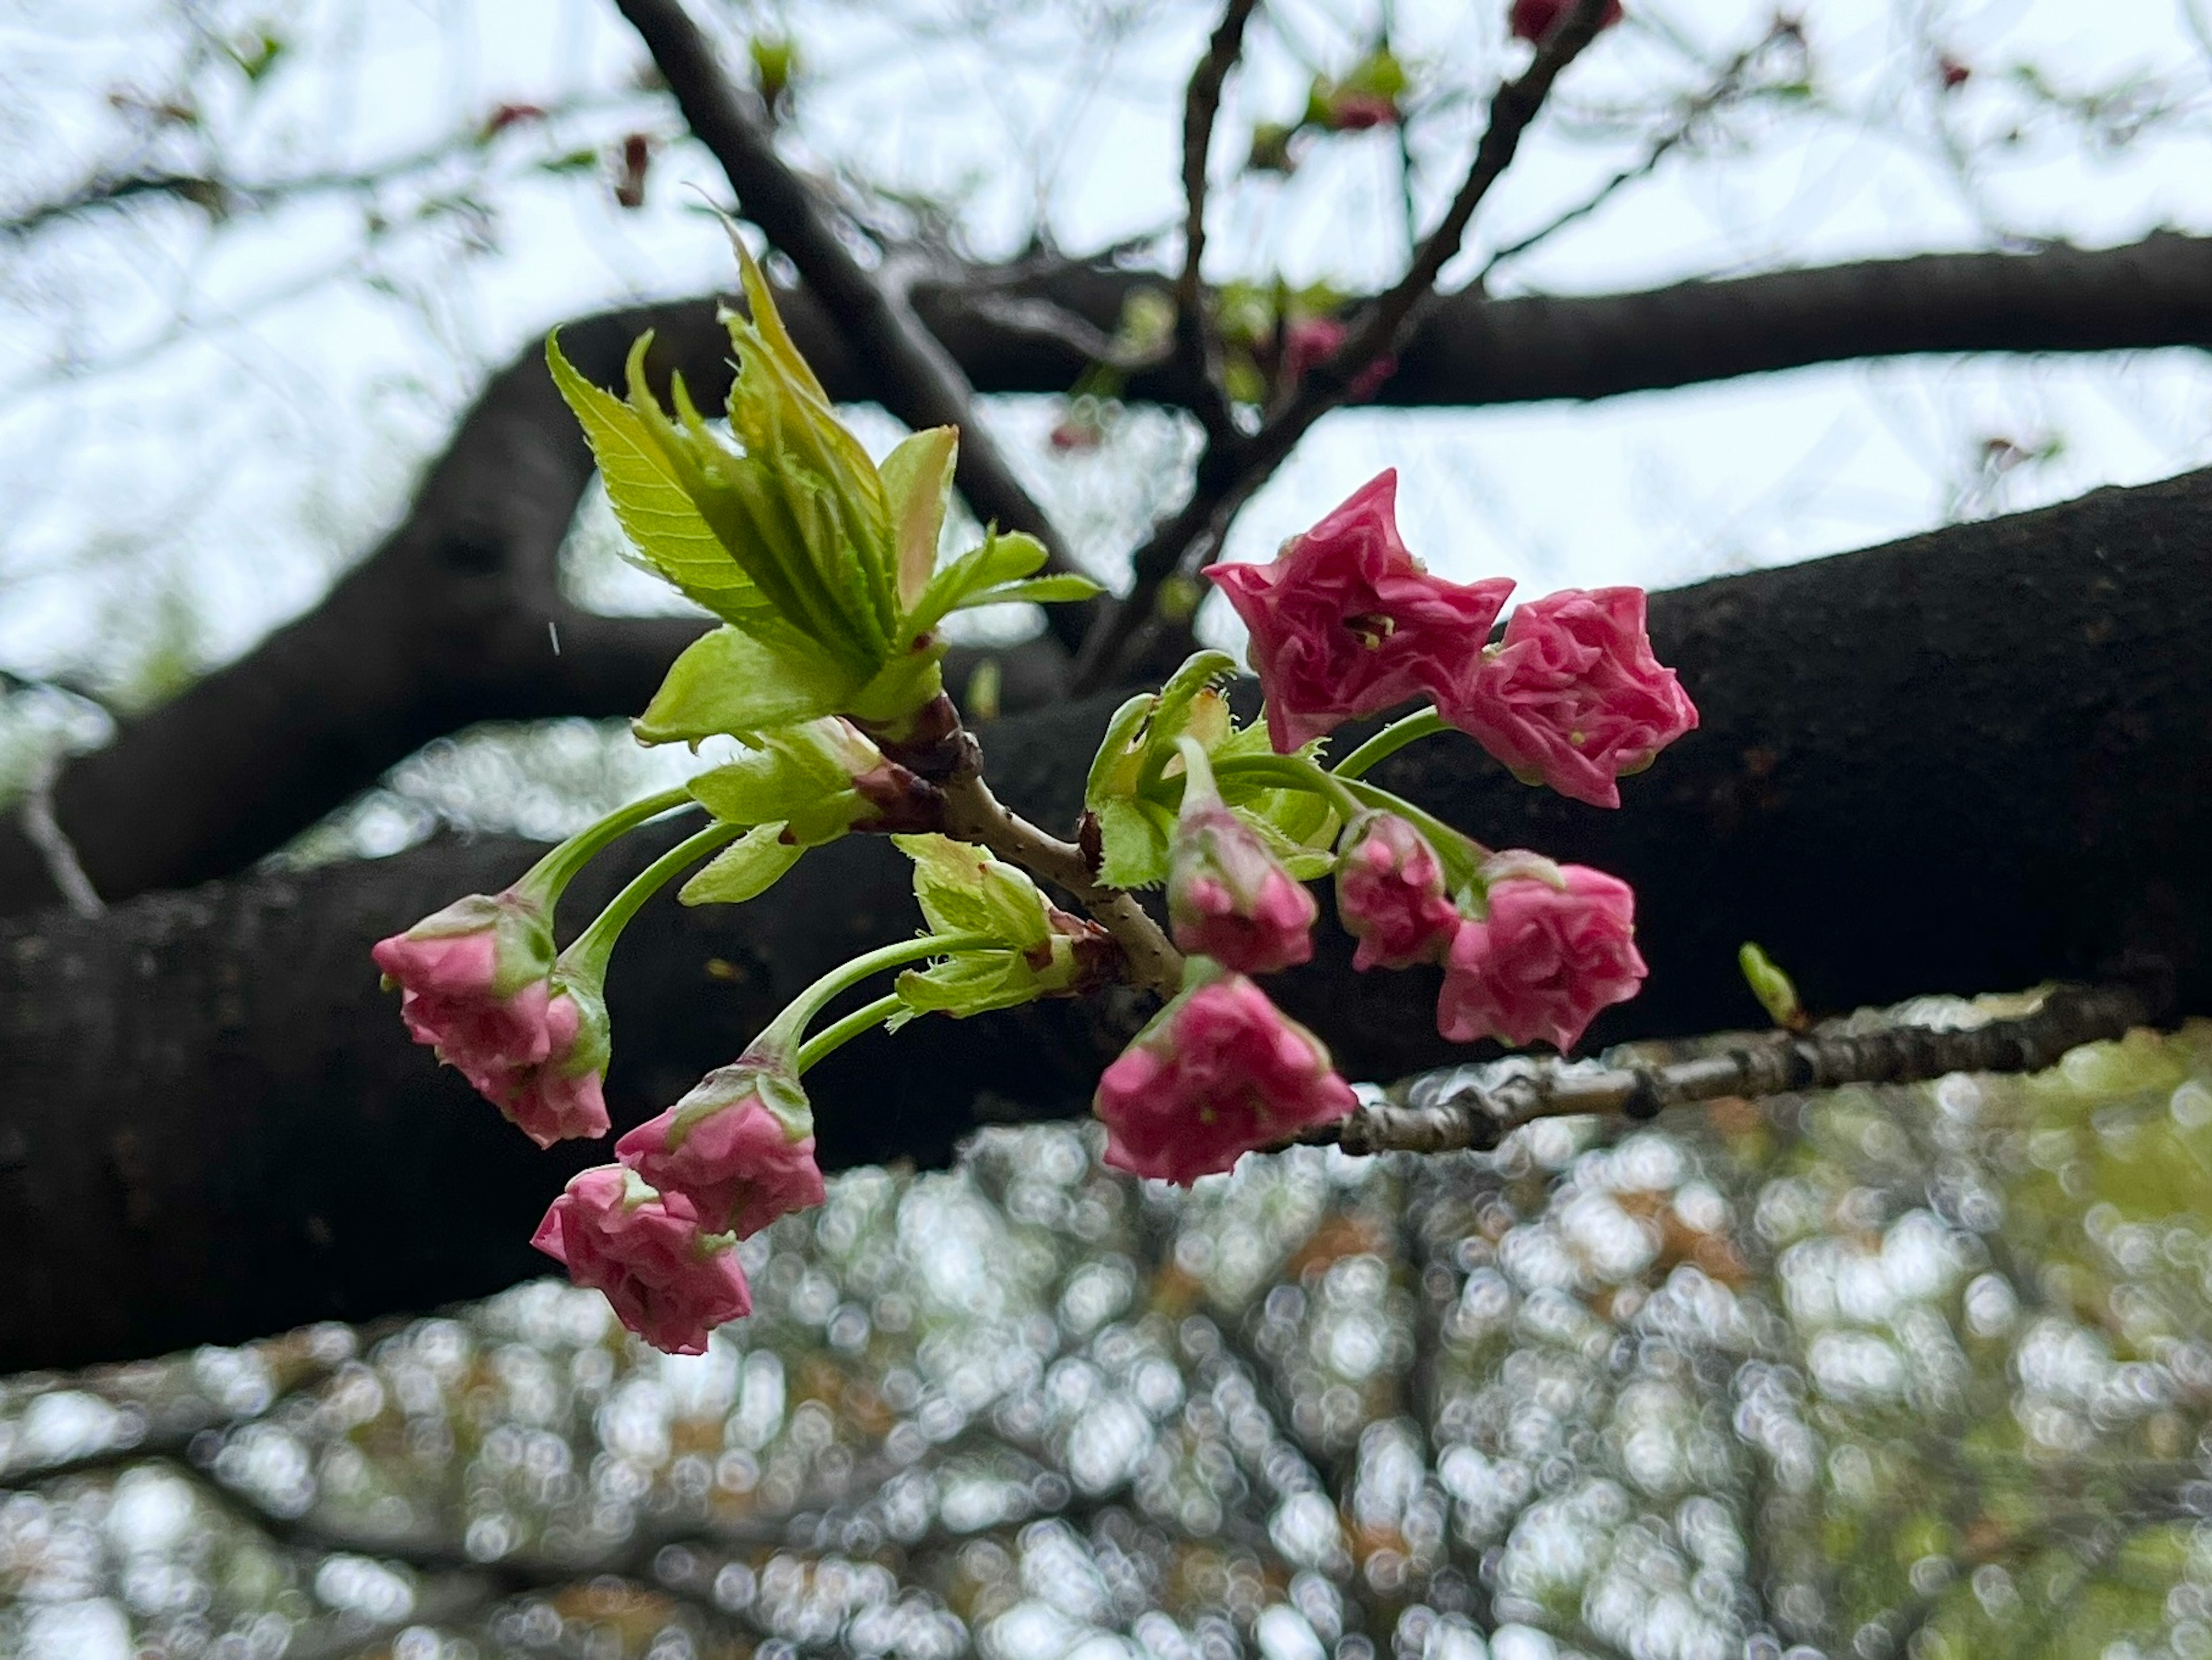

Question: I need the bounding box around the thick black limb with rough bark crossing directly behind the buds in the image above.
[0,471,2212,1370]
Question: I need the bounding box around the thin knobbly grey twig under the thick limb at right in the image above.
[1301,985,2152,1153]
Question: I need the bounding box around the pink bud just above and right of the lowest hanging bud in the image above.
[615,1053,823,1239]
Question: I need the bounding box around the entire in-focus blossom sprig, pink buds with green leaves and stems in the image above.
[374,247,1696,1355]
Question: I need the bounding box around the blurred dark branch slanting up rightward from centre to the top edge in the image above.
[1075,0,1608,690]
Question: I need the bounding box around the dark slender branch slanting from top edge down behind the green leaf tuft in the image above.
[619,0,1084,646]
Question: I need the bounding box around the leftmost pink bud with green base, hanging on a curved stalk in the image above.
[369,887,553,1078]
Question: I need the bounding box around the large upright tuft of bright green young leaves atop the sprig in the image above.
[546,245,1099,744]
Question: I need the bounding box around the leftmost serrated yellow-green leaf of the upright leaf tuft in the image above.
[546,334,770,622]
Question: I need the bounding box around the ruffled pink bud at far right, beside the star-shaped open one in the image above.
[1435,589,1696,808]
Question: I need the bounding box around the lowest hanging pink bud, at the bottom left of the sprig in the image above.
[531,1164,752,1355]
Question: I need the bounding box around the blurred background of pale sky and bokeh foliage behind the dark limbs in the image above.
[0,0,2212,1660]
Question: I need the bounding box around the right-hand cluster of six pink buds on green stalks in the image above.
[1095,471,1696,1182]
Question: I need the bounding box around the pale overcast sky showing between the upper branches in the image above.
[0,0,2212,788]
